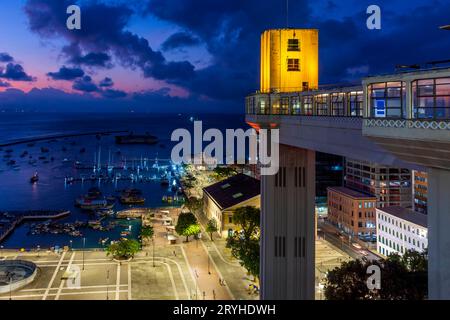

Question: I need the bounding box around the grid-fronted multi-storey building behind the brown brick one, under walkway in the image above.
[345,158,412,208]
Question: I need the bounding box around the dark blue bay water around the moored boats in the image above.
[0,113,248,249]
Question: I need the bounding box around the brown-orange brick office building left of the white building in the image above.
[328,187,377,242]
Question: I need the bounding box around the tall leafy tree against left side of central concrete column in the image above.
[227,206,261,279]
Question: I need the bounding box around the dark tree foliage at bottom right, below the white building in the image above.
[325,250,428,300]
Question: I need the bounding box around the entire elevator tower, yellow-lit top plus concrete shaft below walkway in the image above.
[258,29,318,300]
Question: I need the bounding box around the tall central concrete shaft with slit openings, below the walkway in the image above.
[261,145,315,300]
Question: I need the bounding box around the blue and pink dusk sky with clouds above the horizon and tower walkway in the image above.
[0,0,450,112]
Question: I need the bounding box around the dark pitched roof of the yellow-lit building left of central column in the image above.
[203,173,260,210]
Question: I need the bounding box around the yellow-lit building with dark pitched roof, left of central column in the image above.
[203,173,261,236]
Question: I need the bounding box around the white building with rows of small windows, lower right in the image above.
[377,207,428,256]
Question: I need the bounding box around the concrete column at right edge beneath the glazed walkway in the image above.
[428,168,450,300]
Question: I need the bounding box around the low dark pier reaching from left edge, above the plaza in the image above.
[0,210,70,243]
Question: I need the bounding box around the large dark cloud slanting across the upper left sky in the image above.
[25,0,193,84]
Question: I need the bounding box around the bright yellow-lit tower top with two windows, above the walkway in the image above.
[260,29,319,93]
